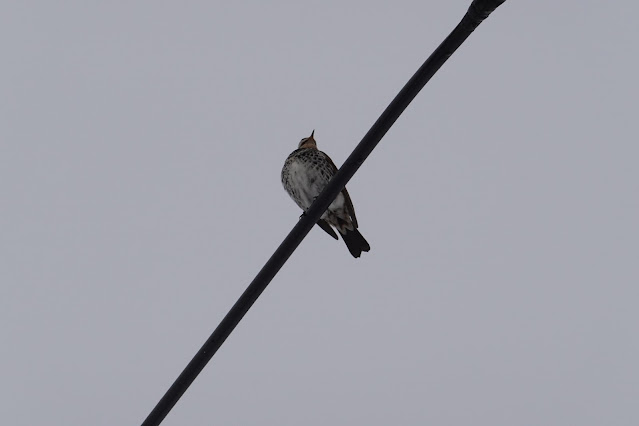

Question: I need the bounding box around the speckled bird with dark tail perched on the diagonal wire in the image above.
[281,130,371,258]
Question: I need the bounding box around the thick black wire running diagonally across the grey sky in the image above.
[142,0,506,426]
